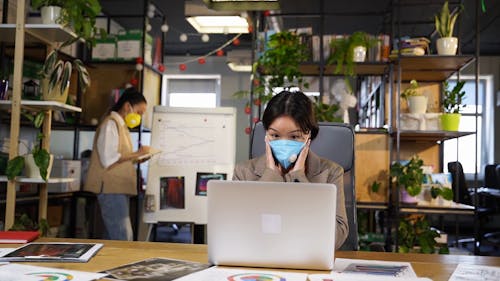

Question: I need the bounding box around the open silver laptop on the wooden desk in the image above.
[207,180,337,270]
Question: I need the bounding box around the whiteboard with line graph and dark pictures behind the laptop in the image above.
[143,106,236,224]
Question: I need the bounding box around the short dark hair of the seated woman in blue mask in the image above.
[262,91,319,140]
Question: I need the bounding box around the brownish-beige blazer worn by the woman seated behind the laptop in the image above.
[233,151,349,249]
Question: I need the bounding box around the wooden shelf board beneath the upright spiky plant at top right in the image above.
[392,55,474,82]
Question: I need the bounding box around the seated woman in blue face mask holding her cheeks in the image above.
[233,91,349,248]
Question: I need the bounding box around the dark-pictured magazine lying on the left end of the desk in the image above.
[0,242,103,262]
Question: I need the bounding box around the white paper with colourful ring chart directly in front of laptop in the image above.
[175,266,307,281]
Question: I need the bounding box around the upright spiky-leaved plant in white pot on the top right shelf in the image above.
[434,1,463,56]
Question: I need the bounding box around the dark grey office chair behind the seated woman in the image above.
[250,122,358,251]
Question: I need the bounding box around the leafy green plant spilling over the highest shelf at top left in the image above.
[32,0,106,46]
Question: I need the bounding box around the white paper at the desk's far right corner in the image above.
[448,263,500,281]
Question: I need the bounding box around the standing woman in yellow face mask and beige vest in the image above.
[84,88,149,240]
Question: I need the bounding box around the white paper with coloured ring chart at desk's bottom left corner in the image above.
[0,263,106,281]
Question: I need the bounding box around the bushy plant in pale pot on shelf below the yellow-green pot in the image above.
[390,155,424,203]
